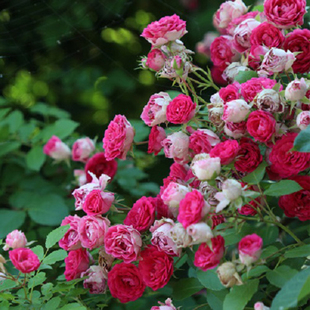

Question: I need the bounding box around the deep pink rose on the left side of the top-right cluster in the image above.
[210,36,239,71]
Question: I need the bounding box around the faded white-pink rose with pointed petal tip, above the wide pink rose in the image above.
[258,47,296,75]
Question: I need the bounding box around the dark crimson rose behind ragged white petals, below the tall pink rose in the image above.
[85,152,117,182]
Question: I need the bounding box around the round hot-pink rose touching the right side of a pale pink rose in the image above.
[167,94,196,124]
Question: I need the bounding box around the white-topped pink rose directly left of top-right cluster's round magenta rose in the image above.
[233,18,260,53]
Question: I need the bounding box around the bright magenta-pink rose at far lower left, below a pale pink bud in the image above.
[9,248,40,273]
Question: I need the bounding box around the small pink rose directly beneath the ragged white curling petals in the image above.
[83,189,114,215]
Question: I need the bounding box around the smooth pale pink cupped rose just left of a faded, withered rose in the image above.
[222,99,251,123]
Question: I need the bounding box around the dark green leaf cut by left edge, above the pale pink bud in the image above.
[0,209,26,238]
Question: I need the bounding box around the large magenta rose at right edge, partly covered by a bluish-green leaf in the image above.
[269,133,310,178]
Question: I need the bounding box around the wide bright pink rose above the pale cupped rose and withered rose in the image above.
[241,77,283,102]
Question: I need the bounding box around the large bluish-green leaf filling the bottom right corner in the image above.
[270,267,310,310]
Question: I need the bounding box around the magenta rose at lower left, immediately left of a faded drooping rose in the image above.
[65,249,89,281]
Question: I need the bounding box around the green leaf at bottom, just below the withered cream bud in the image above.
[223,280,259,310]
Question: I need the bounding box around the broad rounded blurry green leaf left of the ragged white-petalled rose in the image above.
[28,194,69,226]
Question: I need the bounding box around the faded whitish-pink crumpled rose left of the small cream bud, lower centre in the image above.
[150,219,182,256]
